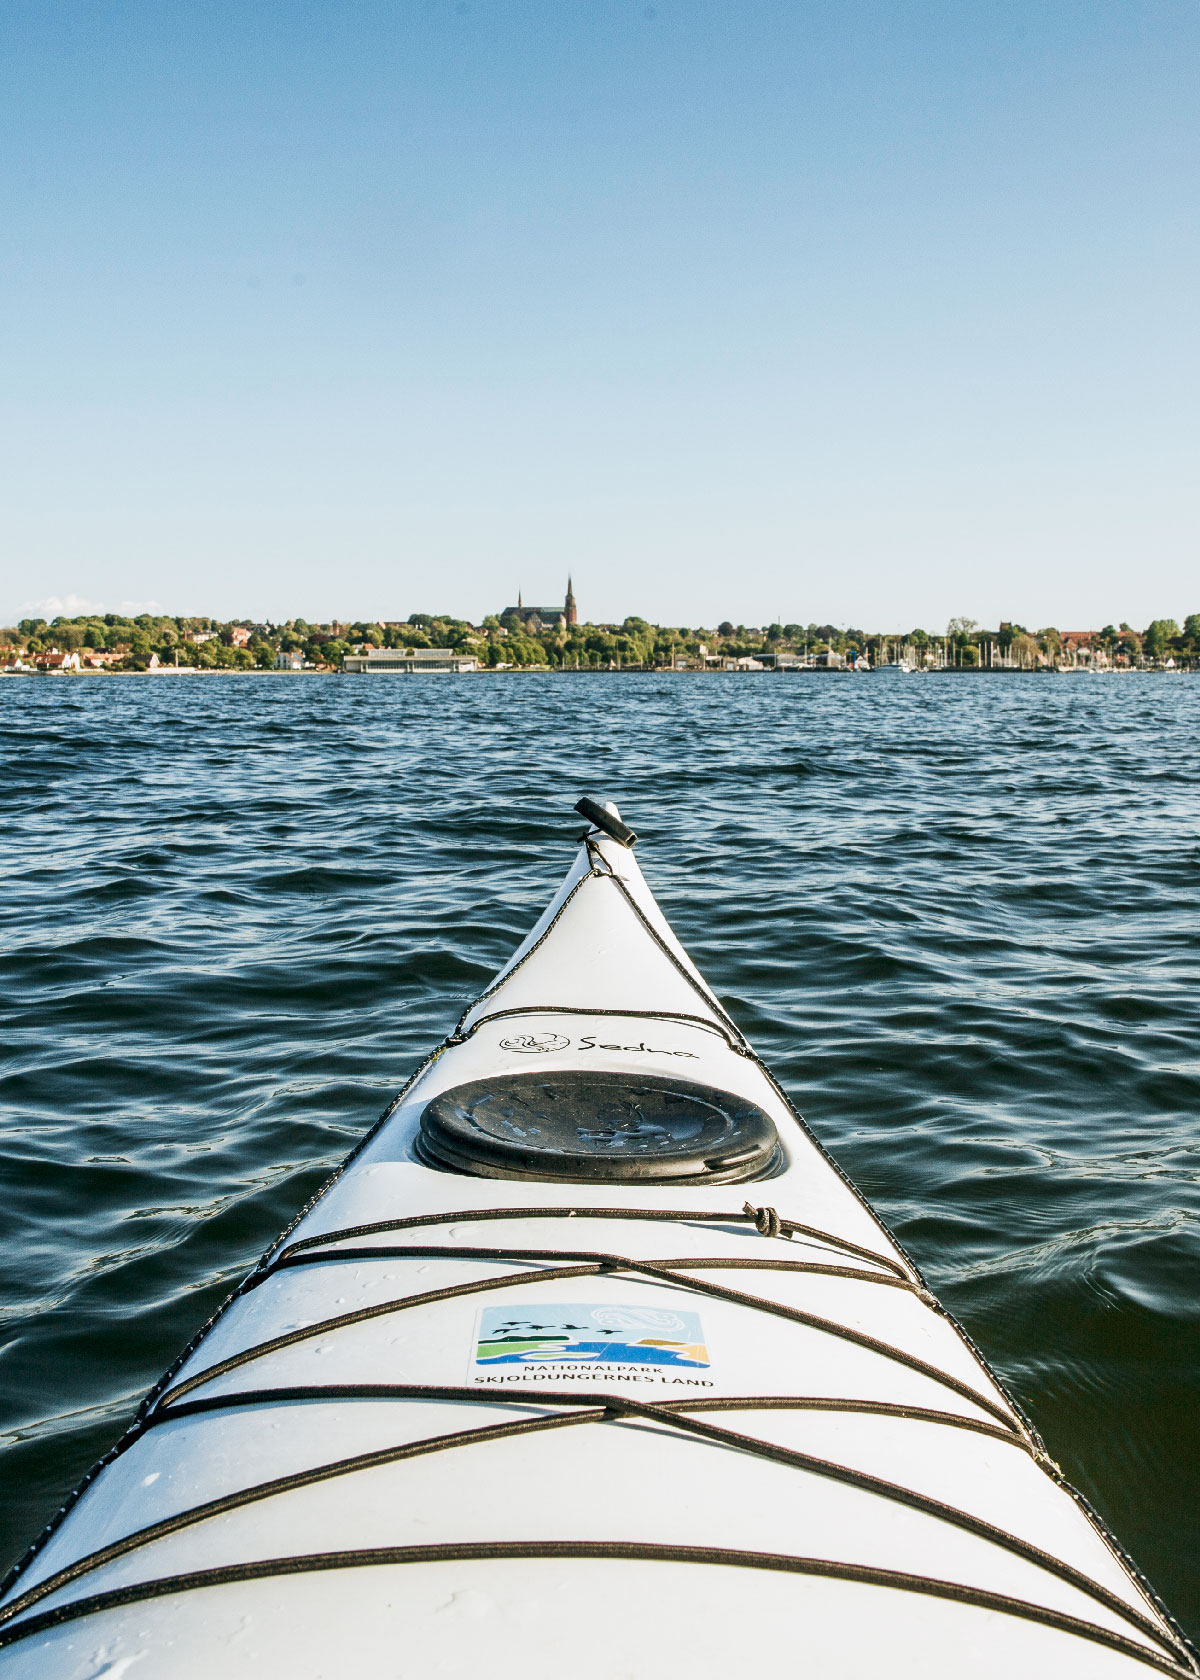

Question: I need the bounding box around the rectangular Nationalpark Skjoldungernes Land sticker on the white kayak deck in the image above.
[471,1304,713,1388]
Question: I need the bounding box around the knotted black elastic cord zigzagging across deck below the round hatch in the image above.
[0,1203,1195,1675]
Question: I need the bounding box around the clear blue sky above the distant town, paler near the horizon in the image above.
[0,0,1200,628]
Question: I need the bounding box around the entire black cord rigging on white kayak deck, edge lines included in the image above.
[0,826,1200,1680]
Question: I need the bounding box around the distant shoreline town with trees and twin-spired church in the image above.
[0,580,1200,675]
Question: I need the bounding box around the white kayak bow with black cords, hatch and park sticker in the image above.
[0,800,1200,1680]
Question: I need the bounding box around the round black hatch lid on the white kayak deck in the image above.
[418,1070,780,1184]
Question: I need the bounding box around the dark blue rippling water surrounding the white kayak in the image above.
[0,675,1200,1636]
